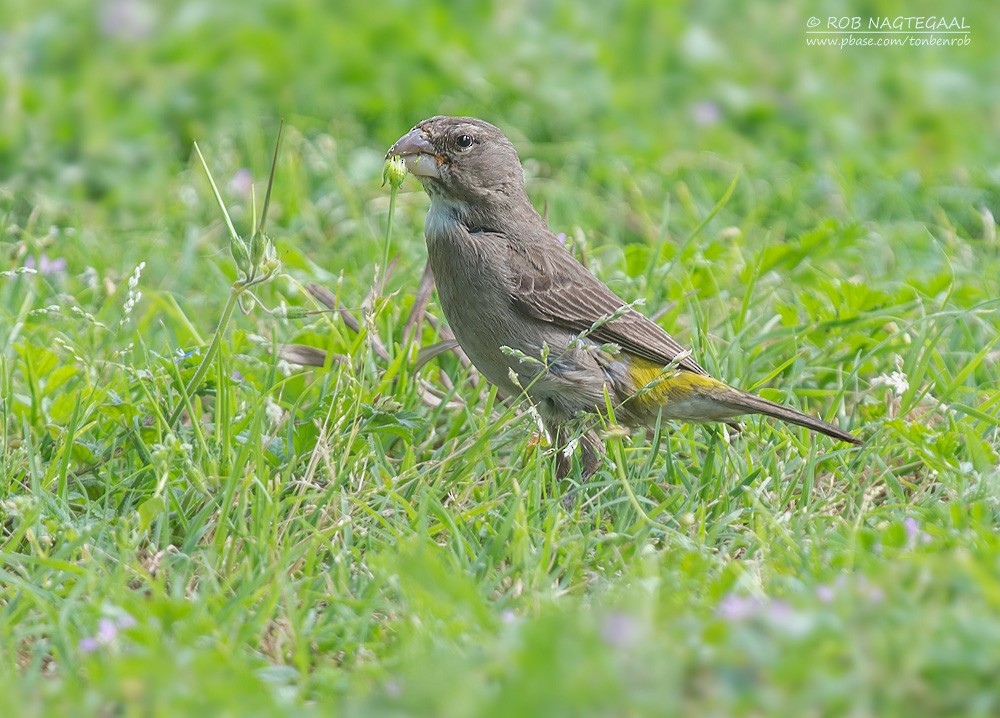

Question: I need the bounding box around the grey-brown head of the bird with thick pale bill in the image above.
[386,115,524,204]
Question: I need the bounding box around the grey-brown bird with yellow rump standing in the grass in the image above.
[386,115,862,478]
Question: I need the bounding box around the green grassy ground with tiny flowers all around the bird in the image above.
[0,0,1000,716]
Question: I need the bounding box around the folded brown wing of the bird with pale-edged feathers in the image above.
[510,227,708,376]
